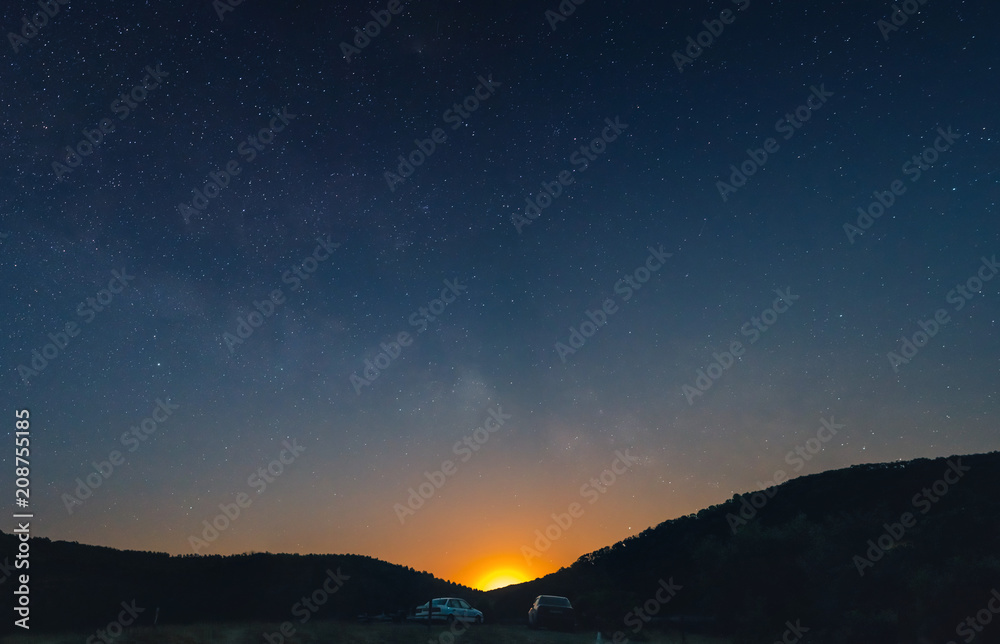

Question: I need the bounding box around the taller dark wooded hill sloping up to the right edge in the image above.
[490,452,1000,644]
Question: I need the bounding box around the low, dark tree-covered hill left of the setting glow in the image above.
[0,544,483,632]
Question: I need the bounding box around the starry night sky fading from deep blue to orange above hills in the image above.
[0,0,1000,587]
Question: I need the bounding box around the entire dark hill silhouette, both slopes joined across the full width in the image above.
[0,452,1000,644]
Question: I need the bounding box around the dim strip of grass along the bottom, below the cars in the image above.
[2,622,728,644]
